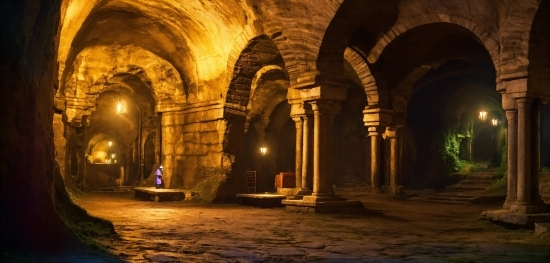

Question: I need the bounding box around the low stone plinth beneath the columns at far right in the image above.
[481,210,550,229]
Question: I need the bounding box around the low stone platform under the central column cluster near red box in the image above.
[282,196,365,214]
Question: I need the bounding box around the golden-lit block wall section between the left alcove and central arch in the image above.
[162,105,230,195]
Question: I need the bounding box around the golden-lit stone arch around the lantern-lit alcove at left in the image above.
[62,45,187,121]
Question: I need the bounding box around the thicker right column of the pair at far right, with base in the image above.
[510,98,547,214]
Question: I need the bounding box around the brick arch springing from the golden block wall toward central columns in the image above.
[225,35,283,115]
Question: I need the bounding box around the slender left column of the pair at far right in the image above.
[503,109,518,209]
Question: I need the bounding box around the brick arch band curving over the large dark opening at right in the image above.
[367,14,500,74]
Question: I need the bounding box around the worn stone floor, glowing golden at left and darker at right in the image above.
[62,192,550,262]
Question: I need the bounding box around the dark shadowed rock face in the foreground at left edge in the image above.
[0,0,69,254]
